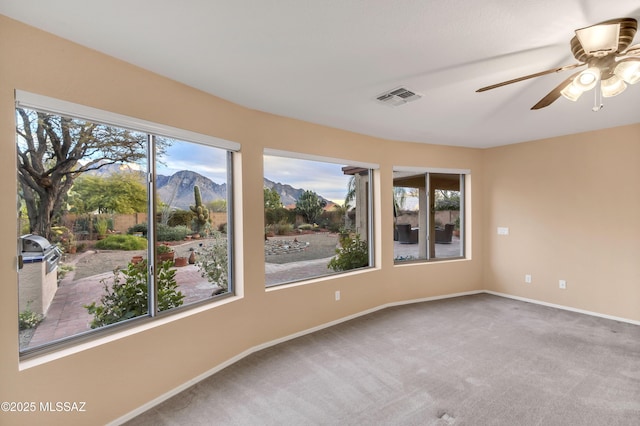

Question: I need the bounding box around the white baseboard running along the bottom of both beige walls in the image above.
[108,290,640,426]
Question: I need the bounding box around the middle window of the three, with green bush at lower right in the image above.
[264,153,373,286]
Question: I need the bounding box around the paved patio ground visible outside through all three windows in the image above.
[21,237,460,349]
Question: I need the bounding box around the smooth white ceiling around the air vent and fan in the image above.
[0,0,640,147]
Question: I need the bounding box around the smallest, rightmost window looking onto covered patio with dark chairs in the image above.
[393,169,468,263]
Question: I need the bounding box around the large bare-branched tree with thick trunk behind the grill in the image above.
[16,108,166,238]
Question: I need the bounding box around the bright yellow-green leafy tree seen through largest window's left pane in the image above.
[69,173,147,214]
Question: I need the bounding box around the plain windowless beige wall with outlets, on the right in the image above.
[483,125,640,321]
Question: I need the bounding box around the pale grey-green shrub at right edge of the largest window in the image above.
[196,231,229,294]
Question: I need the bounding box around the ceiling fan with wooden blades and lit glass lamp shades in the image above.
[476,18,640,111]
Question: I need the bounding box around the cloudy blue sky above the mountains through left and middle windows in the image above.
[156,141,349,204]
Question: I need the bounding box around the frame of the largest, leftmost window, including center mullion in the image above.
[14,90,241,360]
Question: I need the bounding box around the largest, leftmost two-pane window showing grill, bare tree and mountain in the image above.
[16,91,234,353]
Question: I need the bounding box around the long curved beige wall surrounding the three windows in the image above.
[0,16,485,425]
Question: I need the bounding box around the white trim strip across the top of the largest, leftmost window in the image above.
[15,90,240,151]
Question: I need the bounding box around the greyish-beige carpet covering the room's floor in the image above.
[127,294,640,426]
